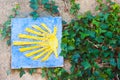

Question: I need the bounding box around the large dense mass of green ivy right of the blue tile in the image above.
[42,1,120,80]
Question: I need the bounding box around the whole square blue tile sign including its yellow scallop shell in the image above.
[11,17,63,69]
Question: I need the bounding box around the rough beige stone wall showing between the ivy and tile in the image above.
[0,0,120,80]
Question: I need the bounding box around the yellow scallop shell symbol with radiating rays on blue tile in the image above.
[13,23,58,61]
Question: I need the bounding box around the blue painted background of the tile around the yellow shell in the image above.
[11,17,64,69]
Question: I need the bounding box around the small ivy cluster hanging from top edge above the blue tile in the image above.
[30,0,59,19]
